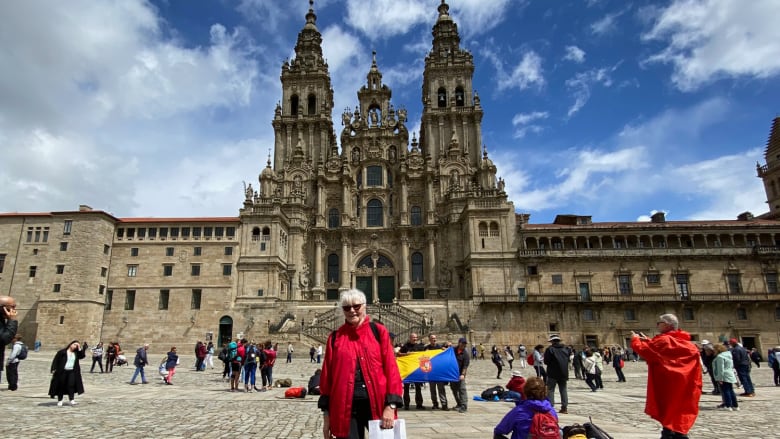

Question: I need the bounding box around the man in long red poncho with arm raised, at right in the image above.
[631,314,702,439]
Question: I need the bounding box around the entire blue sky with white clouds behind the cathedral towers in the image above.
[0,0,780,223]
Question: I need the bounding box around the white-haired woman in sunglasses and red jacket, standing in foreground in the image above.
[317,289,403,439]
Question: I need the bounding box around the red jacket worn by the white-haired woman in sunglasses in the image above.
[318,316,403,437]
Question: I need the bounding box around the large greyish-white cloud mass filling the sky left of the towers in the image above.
[0,0,262,216]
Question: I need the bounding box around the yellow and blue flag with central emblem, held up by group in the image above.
[396,348,460,383]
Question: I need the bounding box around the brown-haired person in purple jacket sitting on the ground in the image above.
[493,377,558,439]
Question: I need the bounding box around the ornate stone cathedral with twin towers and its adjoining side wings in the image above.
[0,0,780,356]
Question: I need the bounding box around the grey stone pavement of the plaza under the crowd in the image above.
[0,351,780,439]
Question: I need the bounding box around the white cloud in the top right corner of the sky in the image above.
[643,0,780,91]
